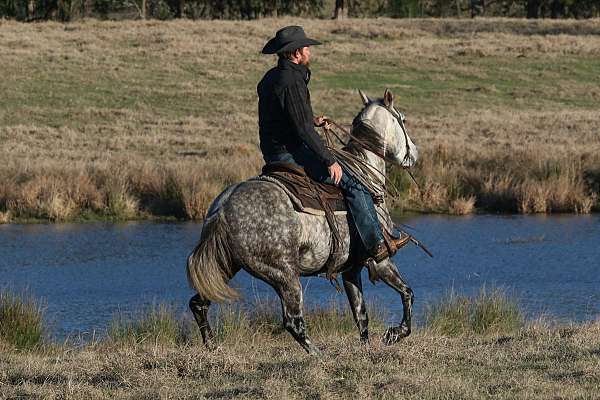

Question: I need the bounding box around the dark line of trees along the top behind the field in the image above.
[0,0,600,21]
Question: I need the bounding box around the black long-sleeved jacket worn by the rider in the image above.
[257,58,335,167]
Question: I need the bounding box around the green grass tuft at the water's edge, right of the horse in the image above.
[425,287,524,336]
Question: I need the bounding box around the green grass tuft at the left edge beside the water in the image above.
[0,289,44,350]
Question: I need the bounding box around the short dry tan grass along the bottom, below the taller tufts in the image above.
[0,316,600,399]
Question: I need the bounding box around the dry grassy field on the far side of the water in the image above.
[0,18,600,222]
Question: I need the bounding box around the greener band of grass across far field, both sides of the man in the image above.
[0,42,600,126]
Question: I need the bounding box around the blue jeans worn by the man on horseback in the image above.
[263,146,383,251]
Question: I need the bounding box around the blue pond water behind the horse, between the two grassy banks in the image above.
[0,216,600,338]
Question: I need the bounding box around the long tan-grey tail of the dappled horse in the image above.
[187,210,239,302]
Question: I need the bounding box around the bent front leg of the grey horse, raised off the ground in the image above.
[375,259,414,344]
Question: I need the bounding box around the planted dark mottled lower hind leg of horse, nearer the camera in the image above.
[273,278,321,355]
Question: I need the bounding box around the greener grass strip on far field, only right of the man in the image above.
[315,56,600,114]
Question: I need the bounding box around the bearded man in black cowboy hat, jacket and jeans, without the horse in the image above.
[257,26,405,263]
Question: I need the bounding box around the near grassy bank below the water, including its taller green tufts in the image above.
[0,293,600,399]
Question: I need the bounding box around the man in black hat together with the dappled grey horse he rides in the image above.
[187,26,418,354]
